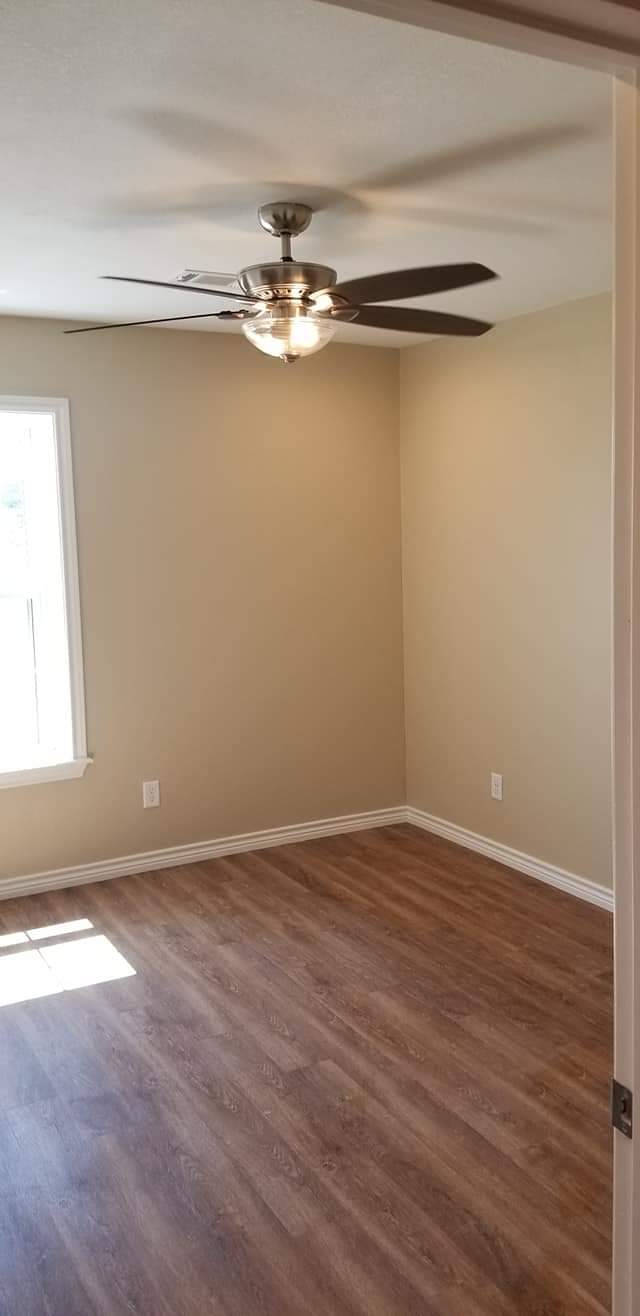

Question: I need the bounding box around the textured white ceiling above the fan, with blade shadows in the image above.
[0,0,611,346]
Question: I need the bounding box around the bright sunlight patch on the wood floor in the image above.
[0,919,136,1007]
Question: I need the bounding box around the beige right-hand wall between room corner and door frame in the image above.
[400,297,611,884]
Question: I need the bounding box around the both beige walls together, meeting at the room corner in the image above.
[0,297,611,883]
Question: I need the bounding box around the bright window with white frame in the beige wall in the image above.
[0,397,88,787]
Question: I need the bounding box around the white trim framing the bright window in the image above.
[0,393,92,790]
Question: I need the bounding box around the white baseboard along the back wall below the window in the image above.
[0,804,407,900]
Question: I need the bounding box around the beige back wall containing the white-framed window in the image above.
[0,318,404,875]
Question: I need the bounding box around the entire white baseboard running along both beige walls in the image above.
[0,804,614,909]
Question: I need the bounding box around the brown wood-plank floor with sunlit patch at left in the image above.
[0,826,612,1316]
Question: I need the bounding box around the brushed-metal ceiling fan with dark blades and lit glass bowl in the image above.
[65,201,496,365]
